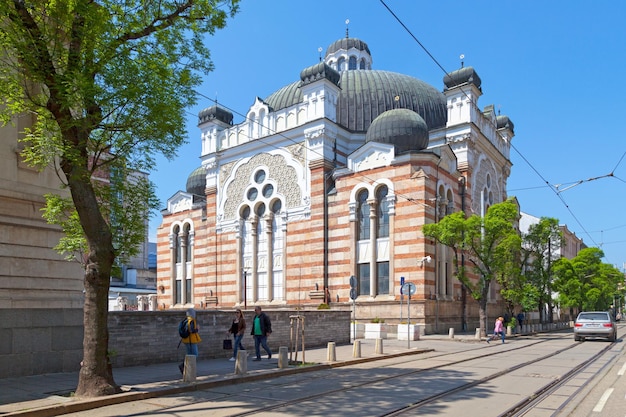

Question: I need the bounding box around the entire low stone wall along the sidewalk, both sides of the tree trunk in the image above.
[0,309,350,378]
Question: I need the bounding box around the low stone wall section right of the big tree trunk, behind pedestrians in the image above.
[109,309,350,367]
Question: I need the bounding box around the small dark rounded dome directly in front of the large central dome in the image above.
[365,109,428,153]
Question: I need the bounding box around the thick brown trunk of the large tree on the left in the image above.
[61,160,120,397]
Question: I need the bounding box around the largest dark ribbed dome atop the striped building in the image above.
[264,70,447,133]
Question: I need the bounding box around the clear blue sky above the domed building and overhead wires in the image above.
[150,0,626,269]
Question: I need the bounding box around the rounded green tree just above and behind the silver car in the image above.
[554,248,624,315]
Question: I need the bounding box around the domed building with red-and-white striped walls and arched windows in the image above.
[157,32,514,331]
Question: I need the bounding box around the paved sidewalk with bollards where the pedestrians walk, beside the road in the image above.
[0,334,484,417]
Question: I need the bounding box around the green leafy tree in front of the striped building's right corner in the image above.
[423,199,521,336]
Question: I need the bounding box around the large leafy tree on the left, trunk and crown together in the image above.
[0,0,238,396]
